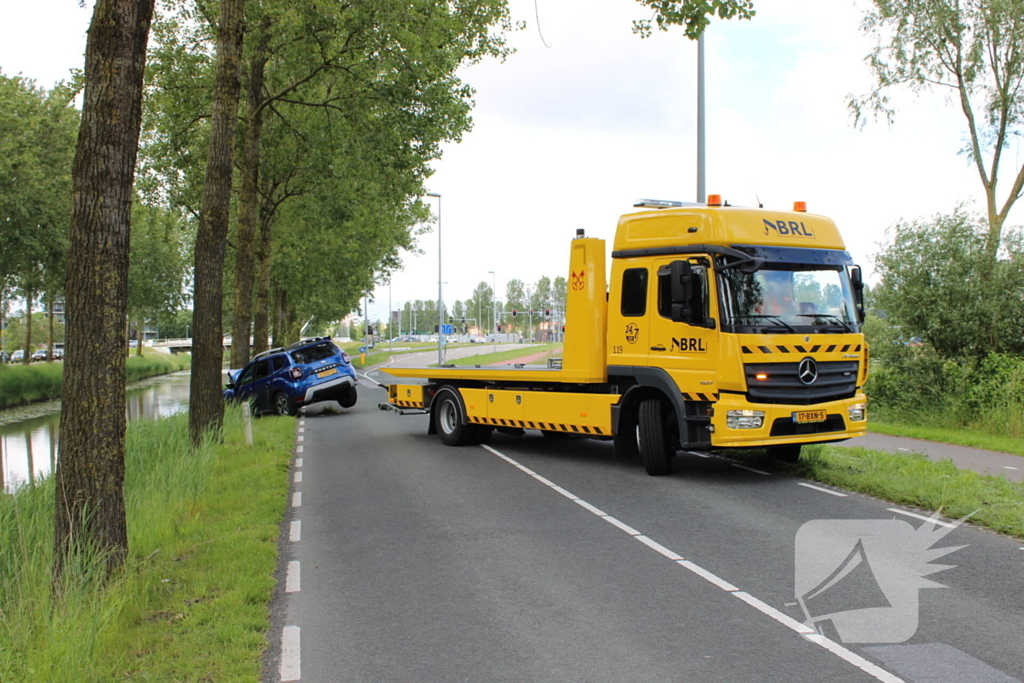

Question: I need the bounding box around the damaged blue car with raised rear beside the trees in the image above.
[224,337,358,415]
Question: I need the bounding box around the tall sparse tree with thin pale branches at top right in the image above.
[849,0,1024,266]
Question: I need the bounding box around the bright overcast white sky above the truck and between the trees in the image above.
[0,0,1024,327]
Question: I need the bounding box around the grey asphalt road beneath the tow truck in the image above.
[264,374,1024,683]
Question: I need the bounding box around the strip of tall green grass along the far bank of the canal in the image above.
[0,352,191,408]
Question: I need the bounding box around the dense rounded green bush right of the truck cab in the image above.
[872,208,1024,358]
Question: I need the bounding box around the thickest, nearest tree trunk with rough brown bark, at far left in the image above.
[53,0,154,587]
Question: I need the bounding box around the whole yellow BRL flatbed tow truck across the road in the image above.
[381,195,867,475]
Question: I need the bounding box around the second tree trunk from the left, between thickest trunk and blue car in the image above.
[188,0,245,445]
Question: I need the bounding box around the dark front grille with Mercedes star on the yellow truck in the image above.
[743,360,860,405]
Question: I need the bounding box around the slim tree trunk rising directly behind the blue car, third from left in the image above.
[231,42,269,368]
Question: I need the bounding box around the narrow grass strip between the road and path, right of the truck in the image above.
[728,445,1024,539]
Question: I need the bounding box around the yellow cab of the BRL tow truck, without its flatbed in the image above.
[607,196,867,469]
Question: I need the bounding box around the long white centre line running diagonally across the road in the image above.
[479,443,905,683]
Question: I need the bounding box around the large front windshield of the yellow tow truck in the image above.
[719,263,857,333]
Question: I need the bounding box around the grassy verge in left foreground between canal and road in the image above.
[0,411,295,683]
